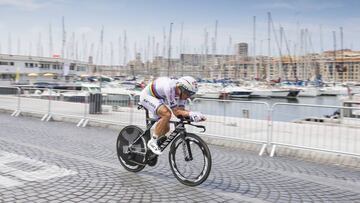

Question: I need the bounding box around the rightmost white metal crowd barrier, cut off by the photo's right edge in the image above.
[270,103,360,156]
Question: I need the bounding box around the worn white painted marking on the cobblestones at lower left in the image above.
[0,151,77,187]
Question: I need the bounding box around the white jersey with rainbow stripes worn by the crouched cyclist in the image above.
[143,77,186,108]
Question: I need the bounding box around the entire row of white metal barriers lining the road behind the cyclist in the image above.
[0,87,360,156]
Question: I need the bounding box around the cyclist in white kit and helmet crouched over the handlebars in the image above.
[140,76,206,155]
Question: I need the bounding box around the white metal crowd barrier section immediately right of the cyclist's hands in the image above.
[190,98,270,153]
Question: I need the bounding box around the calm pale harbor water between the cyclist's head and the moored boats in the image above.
[192,96,341,121]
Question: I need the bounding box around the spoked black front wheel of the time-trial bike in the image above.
[169,133,211,186]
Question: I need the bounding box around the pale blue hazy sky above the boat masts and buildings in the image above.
[0,0,360,64]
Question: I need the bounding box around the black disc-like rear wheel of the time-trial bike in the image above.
[116,125,148,172]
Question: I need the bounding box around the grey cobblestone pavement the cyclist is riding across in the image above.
[0,114,360,202]
